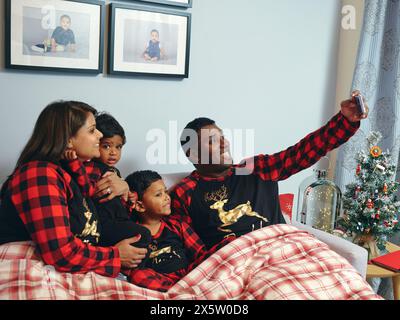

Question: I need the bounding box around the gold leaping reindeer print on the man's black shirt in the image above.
[205,186,268,232]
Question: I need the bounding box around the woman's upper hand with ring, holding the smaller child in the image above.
[94,171,129,203]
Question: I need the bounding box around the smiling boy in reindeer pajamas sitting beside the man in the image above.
[126,171,230,292]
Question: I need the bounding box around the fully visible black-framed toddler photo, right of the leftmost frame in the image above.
[109,3,191,78]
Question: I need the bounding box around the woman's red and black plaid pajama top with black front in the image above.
[0,161,121,277]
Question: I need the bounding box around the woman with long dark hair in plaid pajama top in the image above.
[0,101,146,277]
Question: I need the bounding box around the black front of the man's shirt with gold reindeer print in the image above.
[173,172,285,248]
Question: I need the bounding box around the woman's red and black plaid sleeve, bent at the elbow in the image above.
[10,162,121,277]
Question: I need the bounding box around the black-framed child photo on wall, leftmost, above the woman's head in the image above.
[6,0,105,73]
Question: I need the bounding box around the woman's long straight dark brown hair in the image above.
[16,101,97,168]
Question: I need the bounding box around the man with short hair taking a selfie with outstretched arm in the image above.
[171,92,368,248]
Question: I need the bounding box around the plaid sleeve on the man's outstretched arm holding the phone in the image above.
[250,112,360,181]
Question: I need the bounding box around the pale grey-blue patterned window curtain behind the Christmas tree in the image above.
[335,0,400,198]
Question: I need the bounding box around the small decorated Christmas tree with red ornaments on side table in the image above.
[338,132,400,257]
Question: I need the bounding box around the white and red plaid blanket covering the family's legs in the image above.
[0,225,381,300]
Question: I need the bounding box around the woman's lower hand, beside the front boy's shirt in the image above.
[115,234,147,269]
